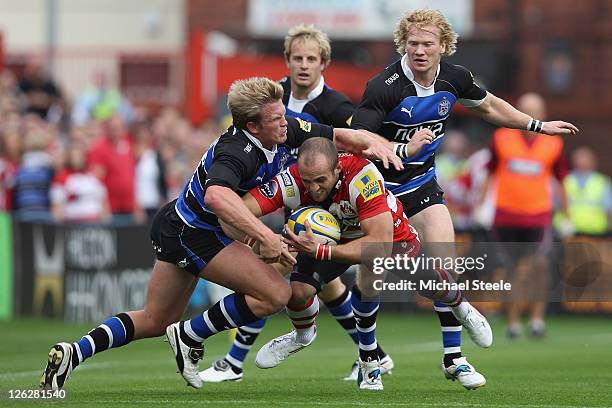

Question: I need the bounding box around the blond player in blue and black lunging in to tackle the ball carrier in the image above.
[40,78,397,389]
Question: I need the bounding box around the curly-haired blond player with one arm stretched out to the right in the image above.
[352,10,578,386]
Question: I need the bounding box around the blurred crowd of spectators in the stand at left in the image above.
[0,59,219,224]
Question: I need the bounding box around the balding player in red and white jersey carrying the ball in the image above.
[220,138,490,390]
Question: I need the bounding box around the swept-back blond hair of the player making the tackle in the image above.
[227,77,283,129]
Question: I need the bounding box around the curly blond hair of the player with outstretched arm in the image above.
[393,9,458,56]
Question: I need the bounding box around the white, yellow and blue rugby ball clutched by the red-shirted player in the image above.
[286,207,342,245]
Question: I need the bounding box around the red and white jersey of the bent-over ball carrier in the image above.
[250,153,417,242]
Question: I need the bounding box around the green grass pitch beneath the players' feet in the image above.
[0,311,612,408]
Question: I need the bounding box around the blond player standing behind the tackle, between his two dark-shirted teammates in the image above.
[200,24,393,382]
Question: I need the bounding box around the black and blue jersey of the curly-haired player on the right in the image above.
[352,56,487,196]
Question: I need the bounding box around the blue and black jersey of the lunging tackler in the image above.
[175,116,333,231]
